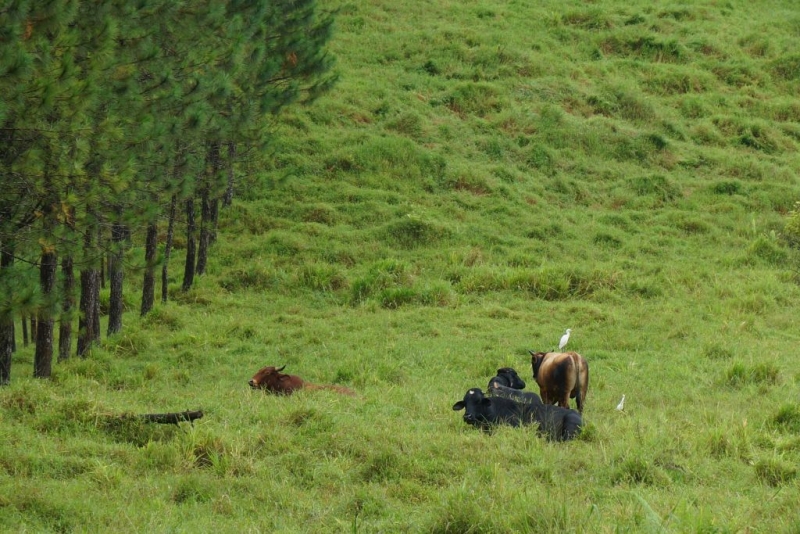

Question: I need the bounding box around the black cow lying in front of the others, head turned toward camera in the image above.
[453,386,583,441]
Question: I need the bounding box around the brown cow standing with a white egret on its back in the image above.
[528,350,589,413]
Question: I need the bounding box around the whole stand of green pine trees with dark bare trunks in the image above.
[0,0,335,384]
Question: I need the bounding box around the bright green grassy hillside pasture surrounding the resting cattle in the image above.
[0,0,800,533]
